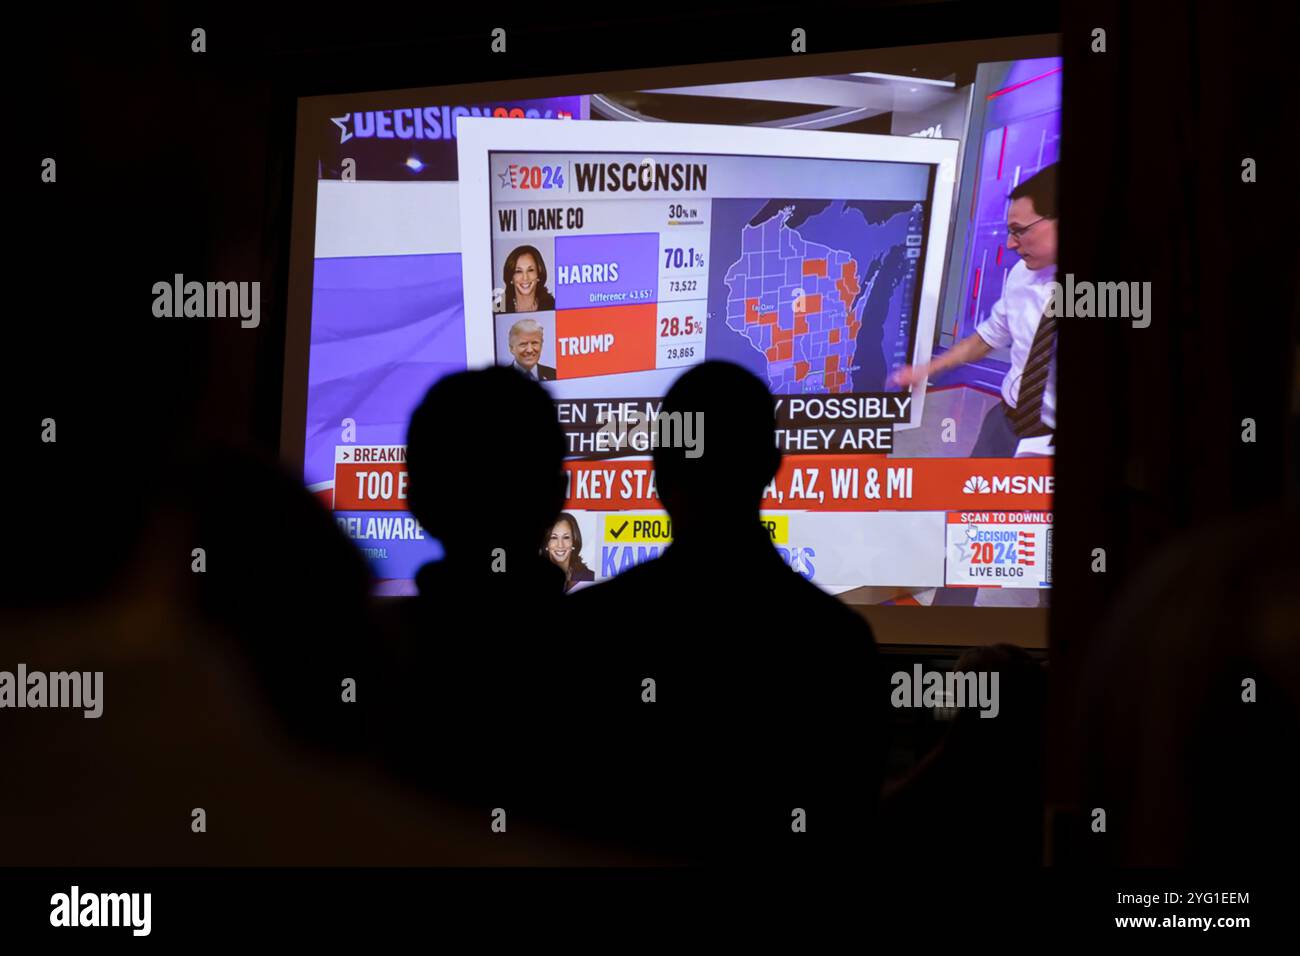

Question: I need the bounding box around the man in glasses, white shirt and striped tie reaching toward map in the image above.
[891,164,1060,458]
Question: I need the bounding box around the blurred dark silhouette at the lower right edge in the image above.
[1074,507,1300,871]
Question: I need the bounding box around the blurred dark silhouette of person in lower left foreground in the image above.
[0,454,623,866]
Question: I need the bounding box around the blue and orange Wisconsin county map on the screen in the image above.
[714,199,920,394]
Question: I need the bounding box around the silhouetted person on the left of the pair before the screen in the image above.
[374,368,624,853]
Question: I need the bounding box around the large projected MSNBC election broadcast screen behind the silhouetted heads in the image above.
[286,50,1060,606]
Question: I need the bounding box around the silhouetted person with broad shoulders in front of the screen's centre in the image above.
[566,362,883,864]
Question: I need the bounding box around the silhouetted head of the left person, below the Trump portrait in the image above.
[407,367,564,566]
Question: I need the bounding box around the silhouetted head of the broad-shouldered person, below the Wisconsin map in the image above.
[654,362,781,536]
